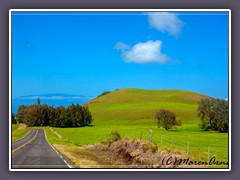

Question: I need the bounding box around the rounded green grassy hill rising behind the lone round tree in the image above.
[86,89,206,123]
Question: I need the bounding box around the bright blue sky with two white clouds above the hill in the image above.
[12,12,228,98]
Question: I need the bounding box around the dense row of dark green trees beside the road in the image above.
[16,103,93,127]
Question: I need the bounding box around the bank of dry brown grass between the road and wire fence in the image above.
[88,138,210,168]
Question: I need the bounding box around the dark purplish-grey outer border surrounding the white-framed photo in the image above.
[0,0,240,180]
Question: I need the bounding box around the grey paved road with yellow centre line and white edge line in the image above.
[12,129,72,169]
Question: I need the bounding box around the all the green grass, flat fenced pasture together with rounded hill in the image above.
[47,89,228,167]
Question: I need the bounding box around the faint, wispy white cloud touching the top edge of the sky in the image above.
[148,12,184,37]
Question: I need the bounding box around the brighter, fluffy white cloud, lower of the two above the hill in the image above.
[115,40,168,64]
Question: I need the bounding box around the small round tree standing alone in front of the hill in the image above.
[155,109,181,130]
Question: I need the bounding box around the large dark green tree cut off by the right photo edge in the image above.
[198,98,229,132]
